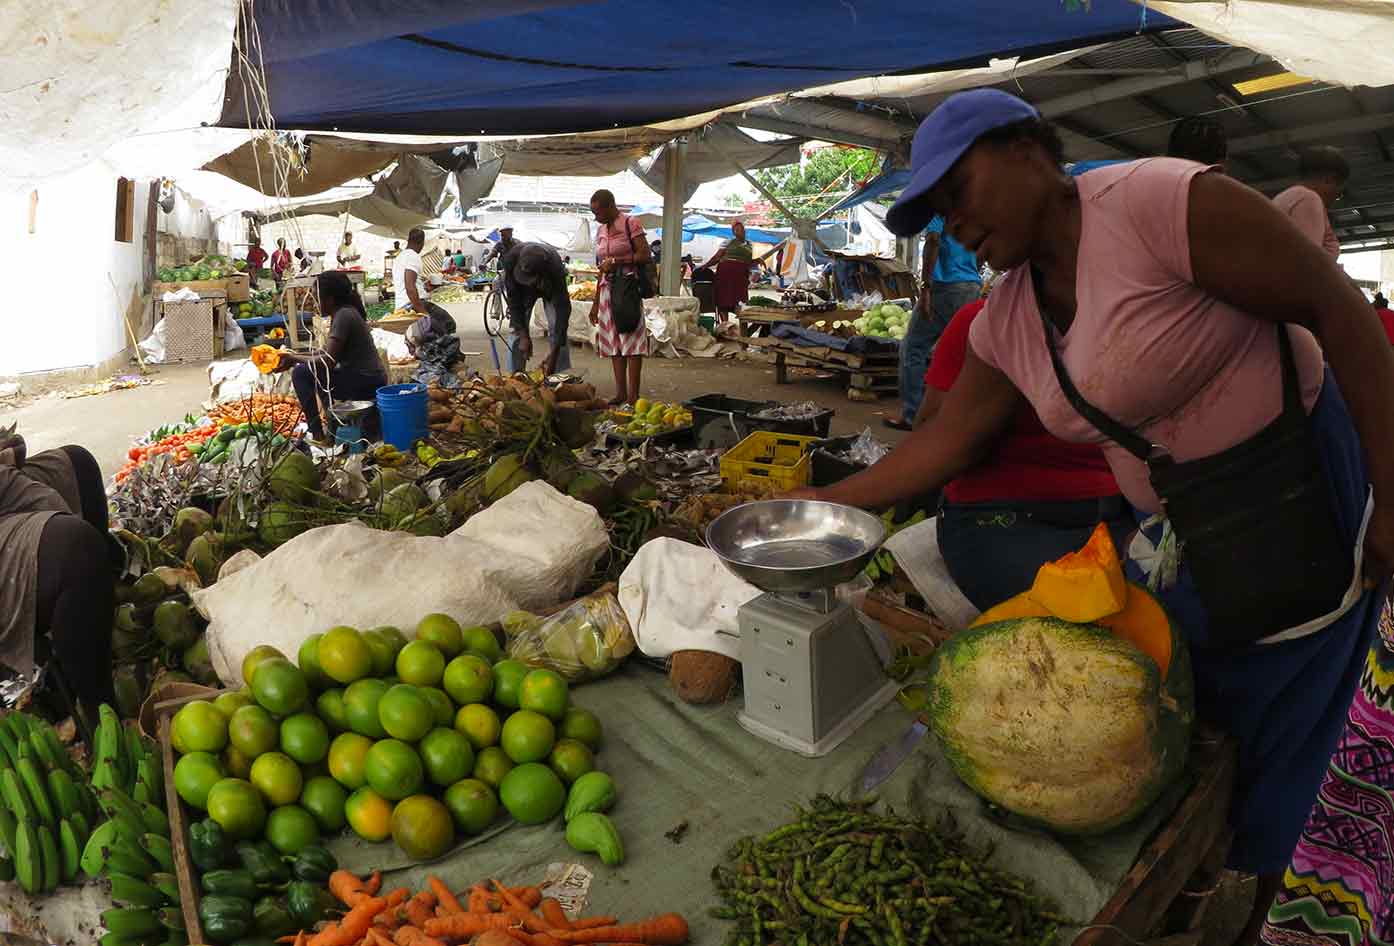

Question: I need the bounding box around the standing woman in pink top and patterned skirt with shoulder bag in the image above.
[591,189,651,404]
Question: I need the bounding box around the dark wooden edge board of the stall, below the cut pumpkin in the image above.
[1075,730,1238,946]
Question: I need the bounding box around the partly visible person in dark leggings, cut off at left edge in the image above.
[0,433,116,726]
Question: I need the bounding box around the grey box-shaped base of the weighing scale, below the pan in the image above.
[737,589,898,758]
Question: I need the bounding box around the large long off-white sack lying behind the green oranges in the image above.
[192,481,609,685]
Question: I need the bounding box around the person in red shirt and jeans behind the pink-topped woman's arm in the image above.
[914,298,1136,610]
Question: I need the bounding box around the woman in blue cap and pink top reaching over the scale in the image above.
[814,89,1394,943]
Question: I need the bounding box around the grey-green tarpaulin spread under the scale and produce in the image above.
[330,660,1181,946]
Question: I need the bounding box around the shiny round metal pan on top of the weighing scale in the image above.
[707,499,885,592]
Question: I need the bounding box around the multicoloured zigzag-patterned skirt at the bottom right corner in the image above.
[1263,602,1394,946]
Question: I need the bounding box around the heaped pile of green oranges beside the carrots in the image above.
[171,614,601,860]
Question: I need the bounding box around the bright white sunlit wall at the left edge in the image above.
[0,162,237,378]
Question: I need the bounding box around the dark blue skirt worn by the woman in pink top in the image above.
[1128,369,1383,874]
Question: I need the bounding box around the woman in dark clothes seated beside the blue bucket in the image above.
[276,272,388,442]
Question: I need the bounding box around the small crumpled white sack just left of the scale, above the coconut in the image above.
[618,539,763,660]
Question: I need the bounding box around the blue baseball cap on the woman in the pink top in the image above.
[885,89,1040,237]
